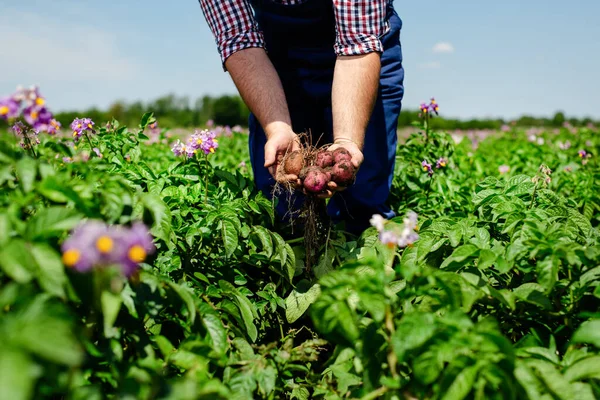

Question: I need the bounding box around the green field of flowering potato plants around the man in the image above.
[0,88,600,400]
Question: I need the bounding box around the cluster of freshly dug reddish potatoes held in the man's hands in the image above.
[283,148,356,194]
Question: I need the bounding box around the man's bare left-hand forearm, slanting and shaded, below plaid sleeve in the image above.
[225,48,292,137]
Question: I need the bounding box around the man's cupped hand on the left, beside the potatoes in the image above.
[265,128,300,184]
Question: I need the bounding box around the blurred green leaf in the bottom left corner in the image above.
[0,347,37,400]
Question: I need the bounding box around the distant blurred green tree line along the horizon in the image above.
[0,94,599,131]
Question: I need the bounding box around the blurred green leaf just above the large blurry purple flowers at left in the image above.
[27,207,82,240]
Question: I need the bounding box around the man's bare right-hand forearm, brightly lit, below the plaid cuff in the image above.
[332,53,381,149]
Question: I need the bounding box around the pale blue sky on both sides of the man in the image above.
[0,0,600,119]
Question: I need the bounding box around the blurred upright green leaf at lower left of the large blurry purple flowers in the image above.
[31,243,67,298]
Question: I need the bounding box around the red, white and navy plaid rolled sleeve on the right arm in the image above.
[333,0,388,56]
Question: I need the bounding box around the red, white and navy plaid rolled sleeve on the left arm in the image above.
[199,0,265,69]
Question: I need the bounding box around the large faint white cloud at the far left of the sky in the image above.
[0,9,141,85]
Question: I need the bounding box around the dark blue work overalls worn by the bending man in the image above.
[249,0,404,234]
